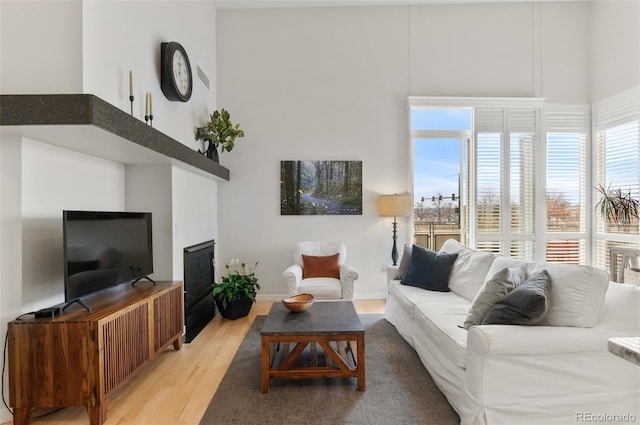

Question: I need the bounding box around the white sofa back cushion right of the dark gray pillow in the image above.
[534,263,609,328]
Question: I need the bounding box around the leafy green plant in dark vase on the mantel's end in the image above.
[196,108,244,162]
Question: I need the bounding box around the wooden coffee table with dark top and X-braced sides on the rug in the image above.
[260,301,365,393]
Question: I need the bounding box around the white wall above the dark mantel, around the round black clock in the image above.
[82,0,216,149]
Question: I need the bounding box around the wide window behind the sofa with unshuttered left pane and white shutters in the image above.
[409,98,544,260]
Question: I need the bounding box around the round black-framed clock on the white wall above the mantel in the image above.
[160,41,193,102]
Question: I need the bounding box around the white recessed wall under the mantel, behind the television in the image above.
[21,139,125,313]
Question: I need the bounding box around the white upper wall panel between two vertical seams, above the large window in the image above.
[405,3,534,96]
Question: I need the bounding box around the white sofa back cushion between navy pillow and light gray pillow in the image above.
[440,239,497,301]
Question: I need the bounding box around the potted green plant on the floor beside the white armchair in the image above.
[211,258,260,320]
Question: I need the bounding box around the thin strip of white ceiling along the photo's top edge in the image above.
[213,0,589,9]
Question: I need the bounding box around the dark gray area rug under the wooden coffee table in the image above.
[200,314,460,425]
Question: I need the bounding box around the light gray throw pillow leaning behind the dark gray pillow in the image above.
[464,265,527,329]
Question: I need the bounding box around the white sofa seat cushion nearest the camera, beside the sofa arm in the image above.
[414,298,469,368]
